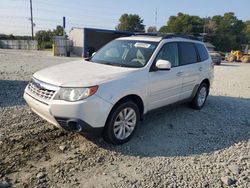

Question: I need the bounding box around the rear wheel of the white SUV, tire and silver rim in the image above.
[190,82,209,110]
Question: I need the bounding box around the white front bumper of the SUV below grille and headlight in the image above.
[24,89,113,132]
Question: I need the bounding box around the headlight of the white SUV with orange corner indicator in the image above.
[55,86,98,102]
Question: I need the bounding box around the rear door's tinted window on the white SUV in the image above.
[179,42,198,65]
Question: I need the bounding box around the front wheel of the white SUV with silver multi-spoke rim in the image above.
[103,101,140,145]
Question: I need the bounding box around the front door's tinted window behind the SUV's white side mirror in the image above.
[156,43,179,67]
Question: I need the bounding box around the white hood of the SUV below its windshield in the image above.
[33,60,138,87]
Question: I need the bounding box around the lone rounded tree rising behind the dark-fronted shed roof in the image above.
[116,14,145,32]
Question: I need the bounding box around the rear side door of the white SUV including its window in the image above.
[178,42,203,100]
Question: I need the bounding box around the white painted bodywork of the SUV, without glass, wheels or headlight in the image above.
[24,37,213,132]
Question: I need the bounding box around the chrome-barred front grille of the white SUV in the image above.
[28,79,56,100]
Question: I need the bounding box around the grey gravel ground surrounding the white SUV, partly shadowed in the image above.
[0,50,250,188]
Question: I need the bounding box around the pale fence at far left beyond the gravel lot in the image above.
[0,40,37,50]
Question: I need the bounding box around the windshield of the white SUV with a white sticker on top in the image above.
[90,40,158,68]
